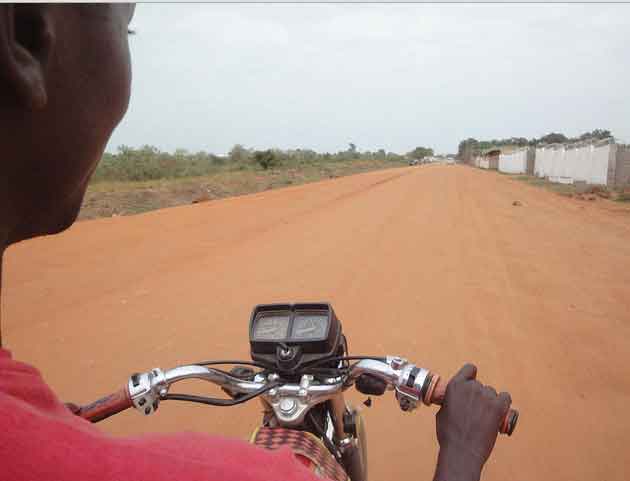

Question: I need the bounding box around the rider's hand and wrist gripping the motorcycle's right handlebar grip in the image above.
[435,364,512,481]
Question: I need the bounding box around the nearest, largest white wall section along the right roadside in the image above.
[534,141,617,185]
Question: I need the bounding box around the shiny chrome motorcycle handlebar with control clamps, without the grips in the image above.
[128,356,435,420]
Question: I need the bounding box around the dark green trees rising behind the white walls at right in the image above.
[457,129,613,159]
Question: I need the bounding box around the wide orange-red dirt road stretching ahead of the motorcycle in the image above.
[2,166,630,481]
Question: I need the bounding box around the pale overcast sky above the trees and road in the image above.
[108,4,630,153]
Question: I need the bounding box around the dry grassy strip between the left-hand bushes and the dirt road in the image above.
[79,160,404,220]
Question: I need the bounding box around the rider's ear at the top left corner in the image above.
[0,4,55,110]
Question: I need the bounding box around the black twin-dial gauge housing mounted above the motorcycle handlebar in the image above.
[249,302,343,372]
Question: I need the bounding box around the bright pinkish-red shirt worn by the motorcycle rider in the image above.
[0,349,321,481]
